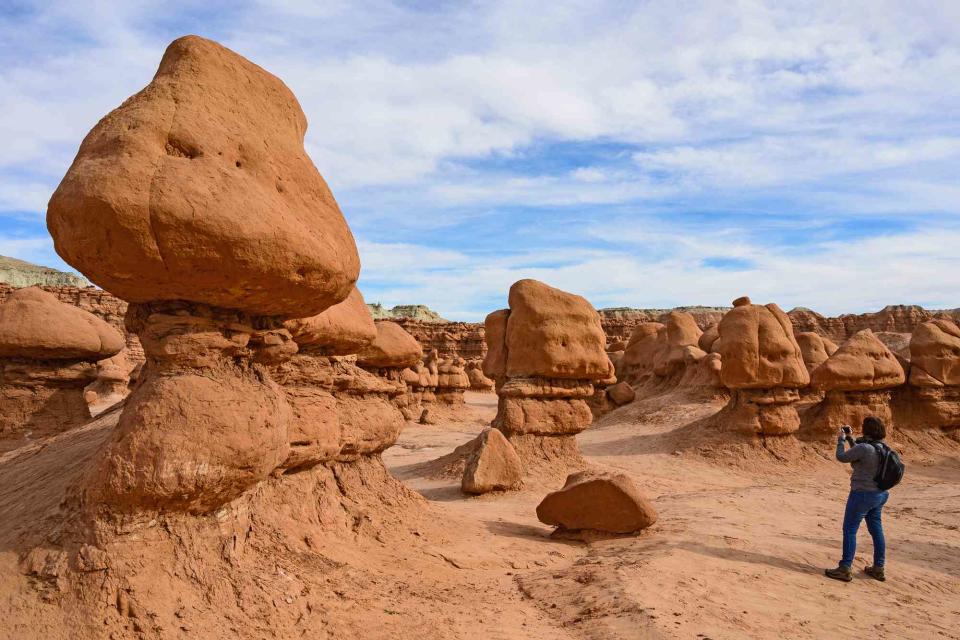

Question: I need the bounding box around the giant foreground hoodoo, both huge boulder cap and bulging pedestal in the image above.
[47,36,359,512]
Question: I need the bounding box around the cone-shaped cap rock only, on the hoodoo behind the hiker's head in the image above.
[811,329,905,391]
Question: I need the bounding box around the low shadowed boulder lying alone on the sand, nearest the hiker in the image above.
[537,471,657,534]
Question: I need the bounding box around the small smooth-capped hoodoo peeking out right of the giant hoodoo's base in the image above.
[357,320,422,420]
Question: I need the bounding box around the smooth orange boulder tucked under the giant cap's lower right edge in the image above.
[284,288,377,355]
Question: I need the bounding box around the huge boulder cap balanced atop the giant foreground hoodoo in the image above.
[47,36,360,317]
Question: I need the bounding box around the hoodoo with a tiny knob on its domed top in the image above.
[718,296,810,436]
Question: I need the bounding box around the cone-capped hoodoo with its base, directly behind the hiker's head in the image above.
[802,329,906,437]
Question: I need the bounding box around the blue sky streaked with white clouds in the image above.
[0,0,960,320]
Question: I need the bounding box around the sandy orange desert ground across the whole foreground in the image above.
[0,392,960,640]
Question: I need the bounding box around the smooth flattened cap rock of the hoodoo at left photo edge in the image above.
[0,287,125,362]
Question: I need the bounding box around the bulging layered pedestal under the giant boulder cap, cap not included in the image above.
[87,303,296,512]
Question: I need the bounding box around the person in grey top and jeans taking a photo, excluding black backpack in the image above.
[824,416,889,582]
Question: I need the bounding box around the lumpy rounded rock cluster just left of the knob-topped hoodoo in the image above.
[617,311,721,395]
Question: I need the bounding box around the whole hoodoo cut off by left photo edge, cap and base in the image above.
[0,287,123,452]
